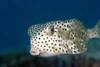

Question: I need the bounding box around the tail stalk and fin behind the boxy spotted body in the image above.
[87,20,100,39]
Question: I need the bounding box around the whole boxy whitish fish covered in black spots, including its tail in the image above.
[28,19,100,57]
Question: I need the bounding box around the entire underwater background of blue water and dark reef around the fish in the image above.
[0,0,100,67]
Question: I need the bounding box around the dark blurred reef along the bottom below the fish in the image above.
[0,52,100,67]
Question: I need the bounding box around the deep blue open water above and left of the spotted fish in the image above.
[0,0,100,50]
